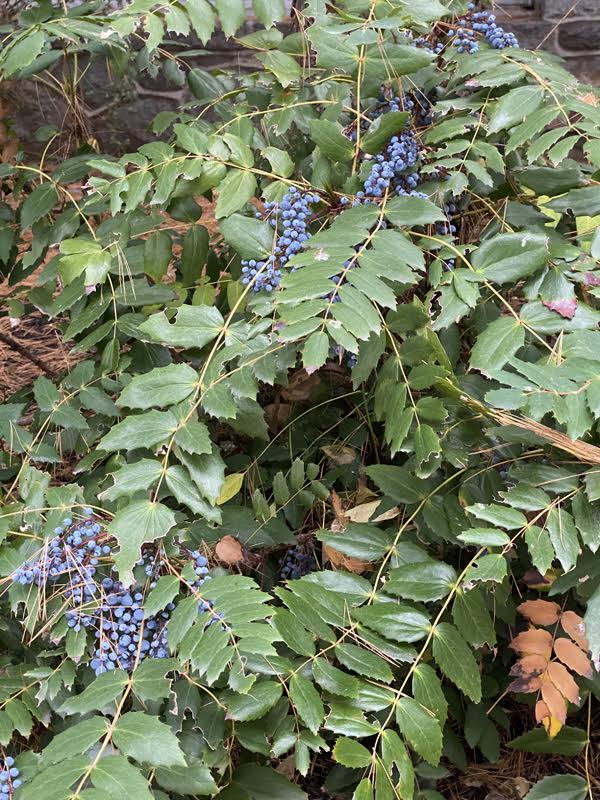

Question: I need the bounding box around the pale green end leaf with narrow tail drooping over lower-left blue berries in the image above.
[108,500,175,586]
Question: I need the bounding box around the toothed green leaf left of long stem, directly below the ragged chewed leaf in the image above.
[118,364,198,409]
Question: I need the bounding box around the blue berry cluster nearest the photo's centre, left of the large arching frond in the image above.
[242,186,320,292]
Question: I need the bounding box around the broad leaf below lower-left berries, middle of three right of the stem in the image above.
[112,711,185,767]
